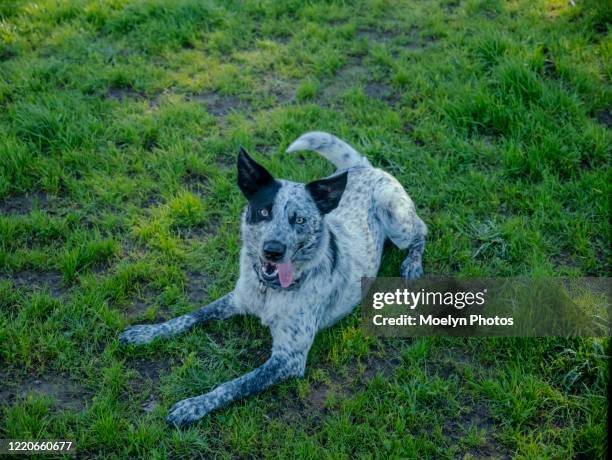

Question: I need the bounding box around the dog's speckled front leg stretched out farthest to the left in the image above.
[119,292,240,345]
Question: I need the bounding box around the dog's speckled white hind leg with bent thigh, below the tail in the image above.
[375,179,427,279]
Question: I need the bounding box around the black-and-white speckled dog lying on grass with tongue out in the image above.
[121,132,427,426]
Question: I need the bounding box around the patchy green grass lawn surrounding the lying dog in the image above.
[0,0,612,458]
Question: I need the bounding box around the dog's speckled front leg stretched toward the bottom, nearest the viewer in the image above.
[166,323,314,426]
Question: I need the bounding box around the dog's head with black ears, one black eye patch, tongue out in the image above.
[238,148,347,288]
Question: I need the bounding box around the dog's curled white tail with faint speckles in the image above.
[287,131,372,169]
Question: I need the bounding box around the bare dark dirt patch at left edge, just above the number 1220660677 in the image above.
[0,374,91,411]
